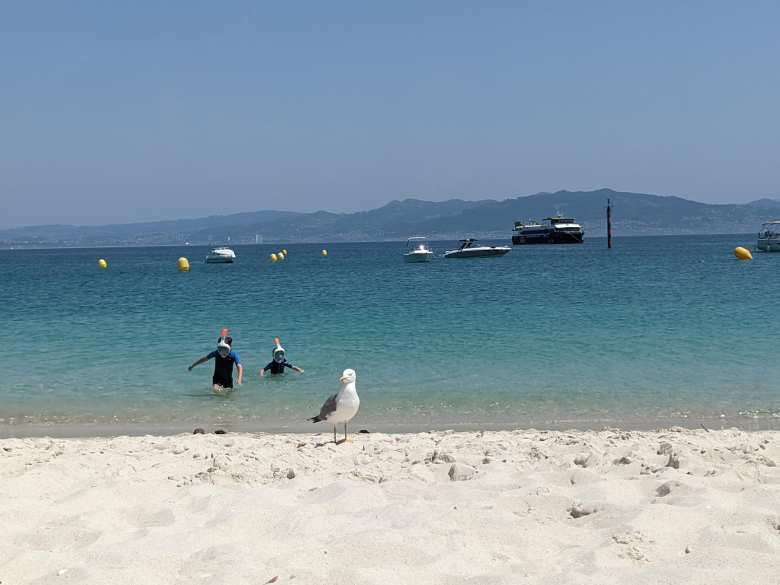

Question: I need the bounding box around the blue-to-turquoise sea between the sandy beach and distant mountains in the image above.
[0,236,780,434]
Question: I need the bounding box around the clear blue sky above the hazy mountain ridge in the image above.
[0,0,780,227]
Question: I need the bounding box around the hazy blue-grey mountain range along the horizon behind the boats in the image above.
[0,189,780,248]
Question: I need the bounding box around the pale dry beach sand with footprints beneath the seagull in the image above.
[0,430,780,585]
